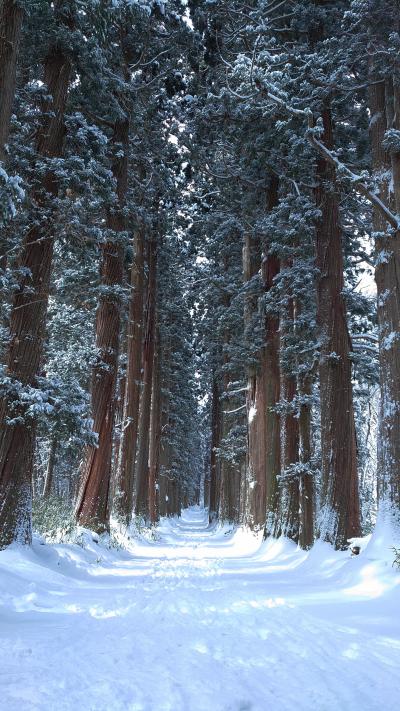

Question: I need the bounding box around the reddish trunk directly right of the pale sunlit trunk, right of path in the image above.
[262,176,281,536]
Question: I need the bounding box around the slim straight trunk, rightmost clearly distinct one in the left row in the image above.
[149,328,161,524]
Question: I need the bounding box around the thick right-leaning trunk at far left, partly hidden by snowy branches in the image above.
[0,33,71,548]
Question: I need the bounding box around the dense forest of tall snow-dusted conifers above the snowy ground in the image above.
[0,0,400,548]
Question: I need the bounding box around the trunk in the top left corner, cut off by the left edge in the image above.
[0,0,24,161]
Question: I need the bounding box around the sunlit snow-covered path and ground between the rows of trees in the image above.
[0,508,400,711]
